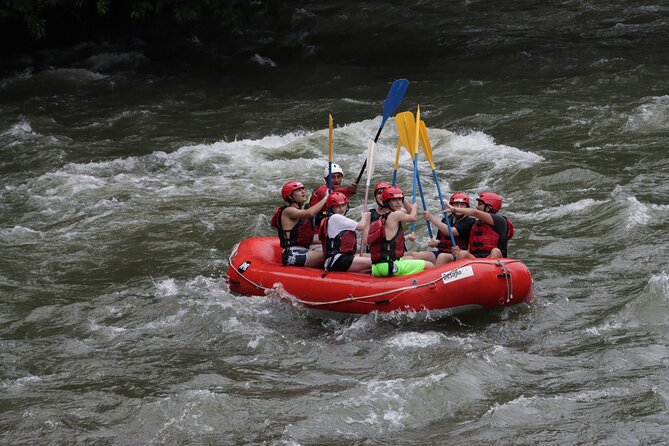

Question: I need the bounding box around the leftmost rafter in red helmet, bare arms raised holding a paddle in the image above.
[272,181,327,267]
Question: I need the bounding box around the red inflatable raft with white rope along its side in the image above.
[227,237,533,317]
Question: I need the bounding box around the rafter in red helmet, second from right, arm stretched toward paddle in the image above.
[423,192,476,265]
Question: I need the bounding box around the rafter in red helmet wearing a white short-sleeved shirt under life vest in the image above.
[318,192,372,276]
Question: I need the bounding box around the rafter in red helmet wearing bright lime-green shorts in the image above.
[367,186,434,277]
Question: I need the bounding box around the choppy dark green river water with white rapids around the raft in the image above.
[0,0,669,445]
